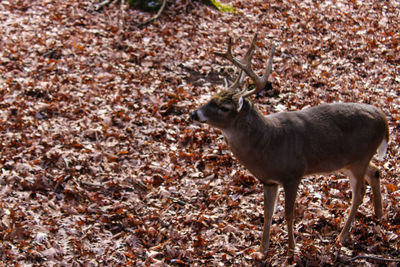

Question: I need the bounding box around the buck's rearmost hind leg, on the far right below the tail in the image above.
[366,162,383,219]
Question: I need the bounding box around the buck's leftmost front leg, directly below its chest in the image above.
[259,184,279,252]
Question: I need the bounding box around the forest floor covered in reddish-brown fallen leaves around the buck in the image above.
[0,0,400,266]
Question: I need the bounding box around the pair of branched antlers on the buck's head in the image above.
[214,34,275,97]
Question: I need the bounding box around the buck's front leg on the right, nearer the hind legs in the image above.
[284,180,298,255]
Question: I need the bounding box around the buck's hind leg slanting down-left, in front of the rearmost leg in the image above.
[338,164,366,243]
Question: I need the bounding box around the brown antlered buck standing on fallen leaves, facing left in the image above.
[191,35,389,253]
